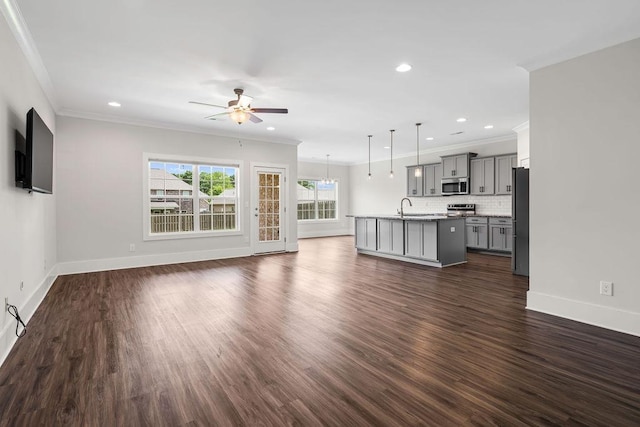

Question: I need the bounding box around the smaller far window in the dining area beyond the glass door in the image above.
[297,180,338,221]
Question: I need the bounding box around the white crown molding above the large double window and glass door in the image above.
[58,108,302,145]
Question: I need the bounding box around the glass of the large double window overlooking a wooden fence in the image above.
[147,160,239,236]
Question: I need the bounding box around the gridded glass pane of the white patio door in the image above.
[258,172,280,242]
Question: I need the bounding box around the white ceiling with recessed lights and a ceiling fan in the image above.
[4,0,640,163]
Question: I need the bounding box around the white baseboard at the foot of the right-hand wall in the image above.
[527,291,640,336]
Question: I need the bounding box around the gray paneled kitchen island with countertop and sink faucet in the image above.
[349,215,467,267]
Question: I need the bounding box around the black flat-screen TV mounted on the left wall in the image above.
[16,108,53,194]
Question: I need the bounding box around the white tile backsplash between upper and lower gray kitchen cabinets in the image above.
[404,196,511,219]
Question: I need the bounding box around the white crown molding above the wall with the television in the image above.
[0,0,58,111]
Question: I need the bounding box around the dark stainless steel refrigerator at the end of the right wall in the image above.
[511,168,529,276]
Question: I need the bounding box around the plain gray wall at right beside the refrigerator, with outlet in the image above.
[527,39,640,335]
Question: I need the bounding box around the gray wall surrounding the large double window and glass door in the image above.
[57,117,297,273]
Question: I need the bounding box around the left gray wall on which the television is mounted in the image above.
[0,16,59,362]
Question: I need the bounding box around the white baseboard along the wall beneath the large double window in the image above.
[58,245,252,275]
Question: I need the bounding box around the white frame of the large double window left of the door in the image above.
[142,153,245,240]
